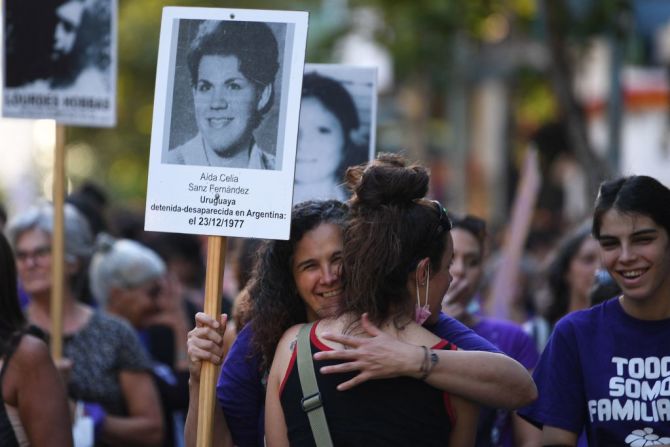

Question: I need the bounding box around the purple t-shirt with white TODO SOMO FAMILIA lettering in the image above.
[519,298,670,447]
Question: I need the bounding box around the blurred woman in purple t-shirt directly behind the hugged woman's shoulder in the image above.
[443,214,541,447]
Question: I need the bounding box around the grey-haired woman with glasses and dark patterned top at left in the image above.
[7,204,162,446]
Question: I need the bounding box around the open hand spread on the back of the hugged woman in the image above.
[314,314,423,391]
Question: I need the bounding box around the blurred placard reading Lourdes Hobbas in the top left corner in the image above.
[2,0,117,127]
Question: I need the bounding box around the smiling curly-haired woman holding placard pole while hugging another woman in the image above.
[185,195,536,447]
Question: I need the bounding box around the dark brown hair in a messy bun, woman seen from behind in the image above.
[342,154,451,325]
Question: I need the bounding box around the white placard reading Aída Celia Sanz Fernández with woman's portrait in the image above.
[145,7,308,239]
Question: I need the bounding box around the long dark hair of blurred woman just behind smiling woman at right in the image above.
[547,227,590,326]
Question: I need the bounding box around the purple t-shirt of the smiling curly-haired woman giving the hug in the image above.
[216,313,501,447]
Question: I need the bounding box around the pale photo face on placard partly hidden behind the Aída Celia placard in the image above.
[295,96,345,183]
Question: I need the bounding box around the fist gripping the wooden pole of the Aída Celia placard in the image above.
[186,312,228,381]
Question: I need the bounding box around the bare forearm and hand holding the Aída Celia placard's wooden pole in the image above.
[184,312,233,447]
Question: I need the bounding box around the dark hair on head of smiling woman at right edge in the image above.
[591,175,670,239]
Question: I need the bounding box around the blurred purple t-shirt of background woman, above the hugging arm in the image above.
[472,318,540,447]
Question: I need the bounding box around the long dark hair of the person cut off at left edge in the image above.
[0,233,26,356]
